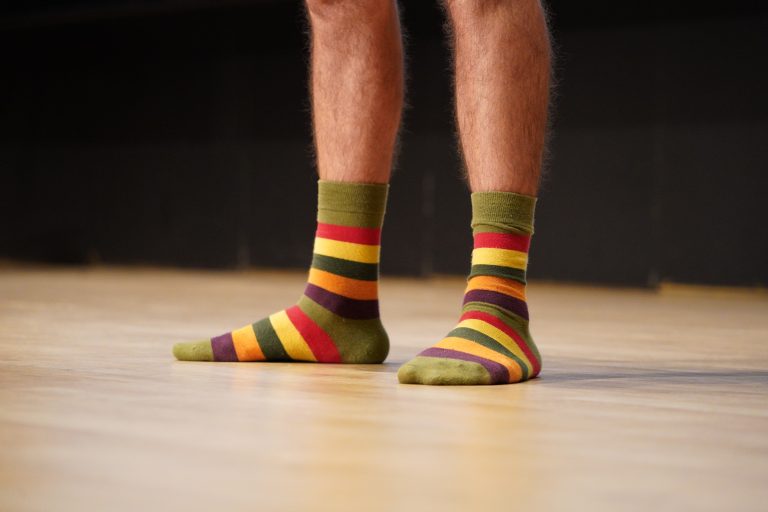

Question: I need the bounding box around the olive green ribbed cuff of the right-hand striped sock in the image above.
[472,192,536,234]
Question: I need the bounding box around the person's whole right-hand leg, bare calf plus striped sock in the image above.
[398,0,550,384]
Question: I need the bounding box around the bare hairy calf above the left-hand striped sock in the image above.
[307,0,403,183]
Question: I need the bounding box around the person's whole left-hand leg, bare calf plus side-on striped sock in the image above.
[173,0,403,363]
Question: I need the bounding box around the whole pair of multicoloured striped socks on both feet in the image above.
[173,180,541,385]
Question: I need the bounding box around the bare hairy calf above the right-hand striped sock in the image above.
[446,0,550,196]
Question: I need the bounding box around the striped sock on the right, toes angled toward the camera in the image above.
[397,192,541,385]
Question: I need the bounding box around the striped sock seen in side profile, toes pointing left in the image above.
[173,180,389,363]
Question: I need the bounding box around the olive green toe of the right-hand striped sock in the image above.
[397,356,491,386]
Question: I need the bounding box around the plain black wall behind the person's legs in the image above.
[0,0,768,286]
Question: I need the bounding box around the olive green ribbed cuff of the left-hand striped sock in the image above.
[317,180,389,227]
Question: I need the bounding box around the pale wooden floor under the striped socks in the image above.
[0,267,768,512]
